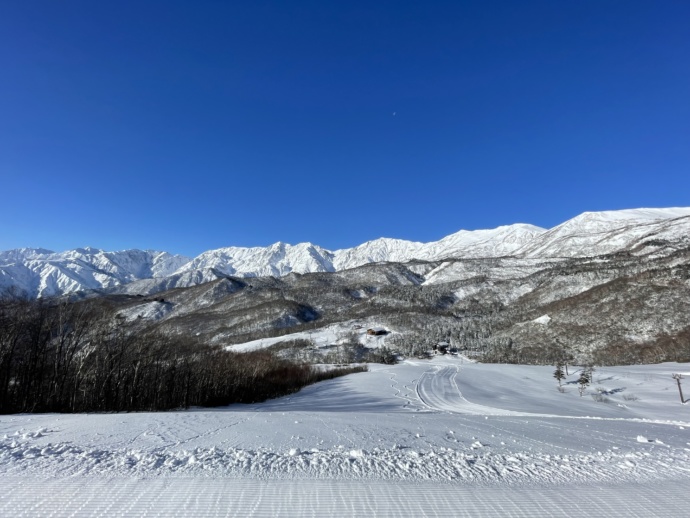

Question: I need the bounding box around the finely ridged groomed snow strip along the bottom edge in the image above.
[0,477,690,518]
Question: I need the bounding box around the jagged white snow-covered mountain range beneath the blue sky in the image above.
[0,207,690,297]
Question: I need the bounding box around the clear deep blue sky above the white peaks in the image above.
[0,0,690,255]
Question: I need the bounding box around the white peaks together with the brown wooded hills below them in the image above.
[0,208,690,364]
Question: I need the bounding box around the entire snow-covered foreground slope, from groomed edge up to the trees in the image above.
[0,357,690,516]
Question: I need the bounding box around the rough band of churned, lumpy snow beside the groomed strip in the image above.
[0,426,690,485]
